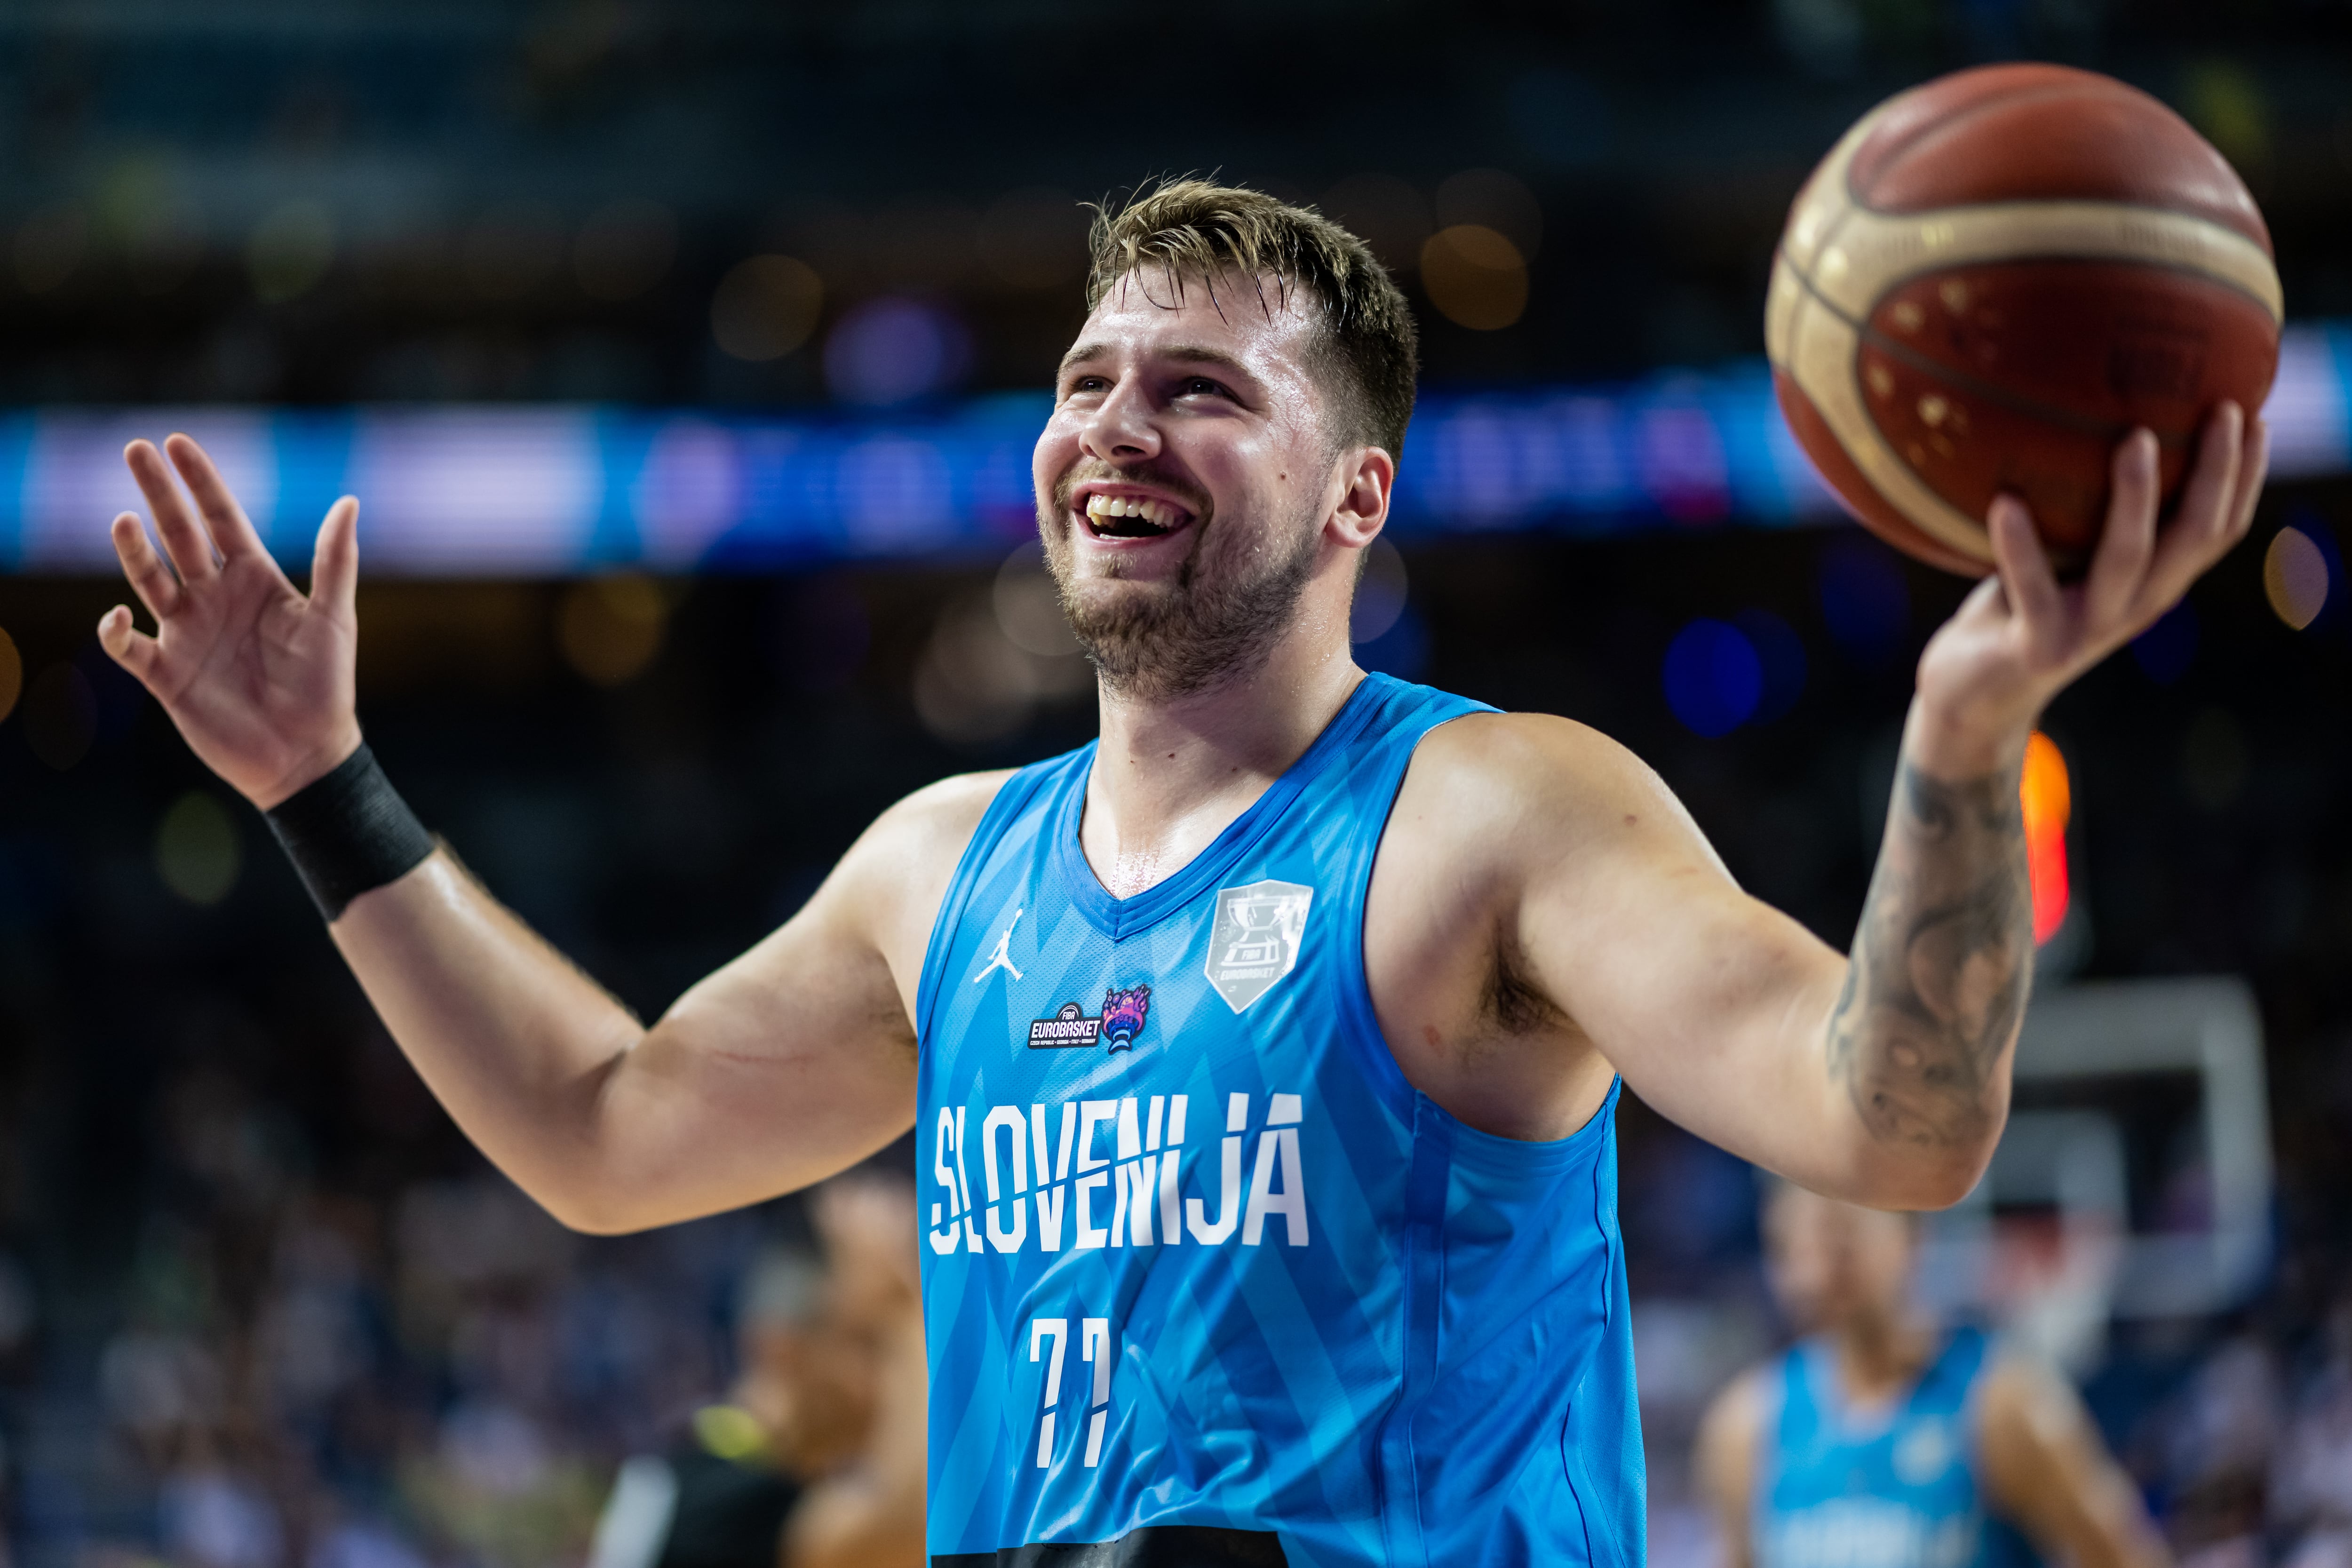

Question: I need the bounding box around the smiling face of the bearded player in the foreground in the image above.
[1033,271,1334,696]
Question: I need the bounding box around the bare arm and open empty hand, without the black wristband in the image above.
[99,435,974,1229]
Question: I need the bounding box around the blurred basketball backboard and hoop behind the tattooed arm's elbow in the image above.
[1922,978,2272,1370]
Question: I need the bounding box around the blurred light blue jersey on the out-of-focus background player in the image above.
[1755,1328,1987,1568]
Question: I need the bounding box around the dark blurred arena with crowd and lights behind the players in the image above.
[0,0,2352,1568]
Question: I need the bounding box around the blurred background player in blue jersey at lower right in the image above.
[1698,1182,2169,1568]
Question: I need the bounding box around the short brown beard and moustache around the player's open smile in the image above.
[1037,468,1317,700]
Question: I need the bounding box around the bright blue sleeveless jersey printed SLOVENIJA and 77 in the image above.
[917,675,1644,1568]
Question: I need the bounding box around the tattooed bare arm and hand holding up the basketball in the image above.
[1503,404,2267,1208]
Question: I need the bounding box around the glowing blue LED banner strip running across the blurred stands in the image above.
[0,325,2352,576]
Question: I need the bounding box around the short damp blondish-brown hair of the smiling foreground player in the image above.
[1087,179,1421,456]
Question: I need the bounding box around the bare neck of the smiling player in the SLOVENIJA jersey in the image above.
[1080,625,1364,898]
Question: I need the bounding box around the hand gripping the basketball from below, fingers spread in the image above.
[1912,402,2270,778]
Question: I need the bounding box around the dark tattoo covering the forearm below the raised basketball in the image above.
[1828,762,2034,1147]
